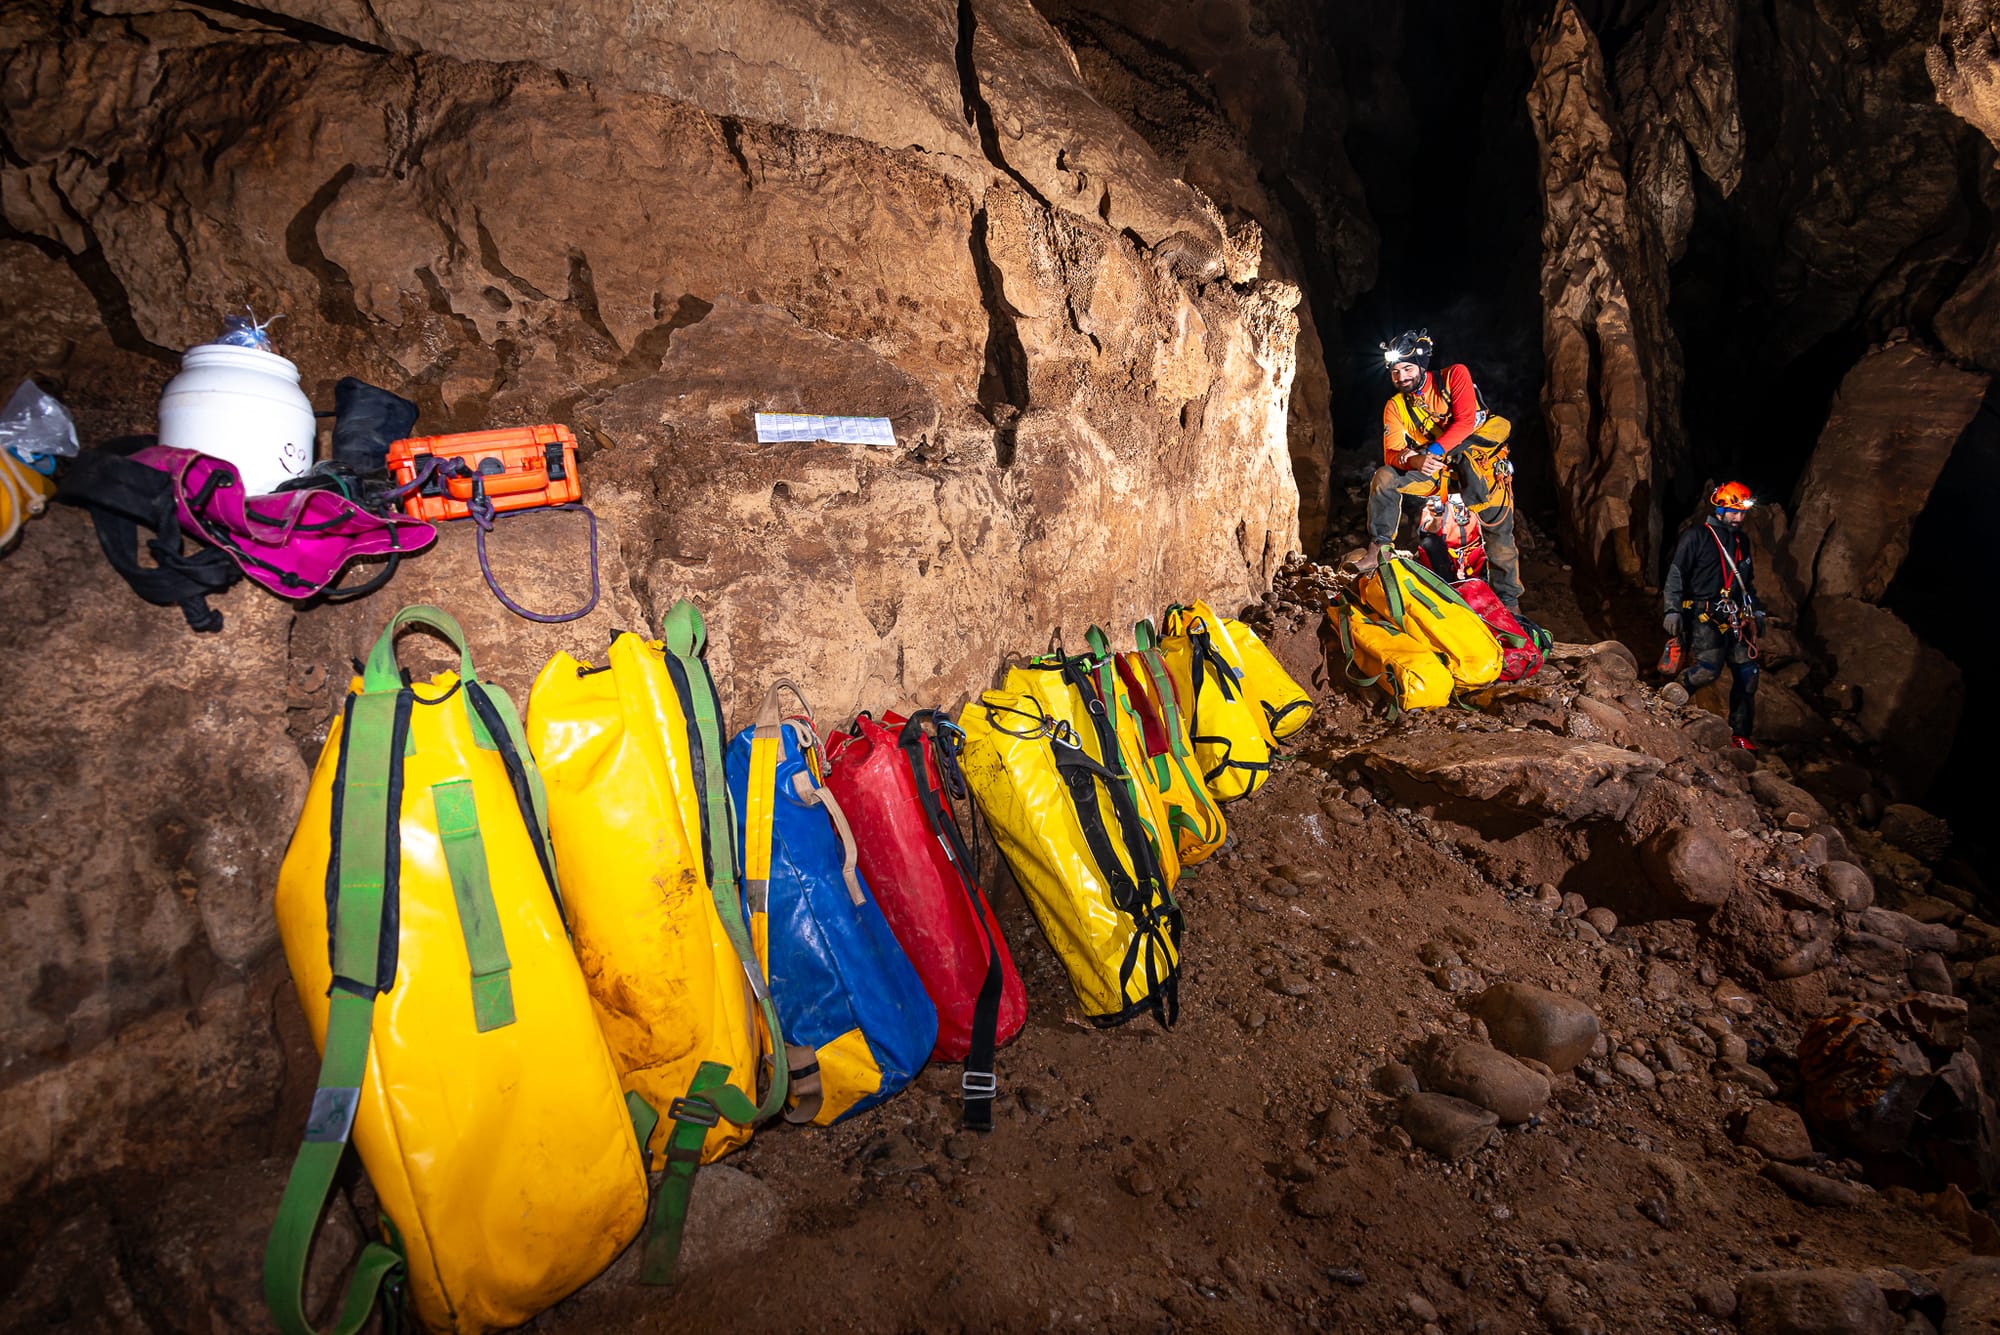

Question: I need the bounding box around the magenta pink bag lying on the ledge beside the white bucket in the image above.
[132,446,438,598]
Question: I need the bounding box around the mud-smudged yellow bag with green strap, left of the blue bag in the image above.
[526,602,786,1283]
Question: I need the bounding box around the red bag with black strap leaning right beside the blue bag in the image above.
[826,709,1028,1131]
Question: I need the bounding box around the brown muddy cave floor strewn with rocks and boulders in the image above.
[0,493,2000,1333]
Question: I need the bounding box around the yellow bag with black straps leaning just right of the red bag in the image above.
[958,666,1182,1027]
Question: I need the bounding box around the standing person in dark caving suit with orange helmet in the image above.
[1664,482,1764,751]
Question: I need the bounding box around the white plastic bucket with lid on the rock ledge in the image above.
[160,344,314,496]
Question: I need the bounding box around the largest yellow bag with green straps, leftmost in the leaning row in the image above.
[264,608,646,1335]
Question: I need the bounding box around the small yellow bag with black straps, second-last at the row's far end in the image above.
[1160,602,1272,801]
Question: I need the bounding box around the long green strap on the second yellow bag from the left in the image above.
[640,600,788,1283]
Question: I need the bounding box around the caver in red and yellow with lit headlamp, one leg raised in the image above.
[1368,330,1522,612]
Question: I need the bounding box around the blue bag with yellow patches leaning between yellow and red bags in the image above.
[726,681,938,1125]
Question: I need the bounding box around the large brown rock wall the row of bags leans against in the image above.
[0,0,1300,1201]
